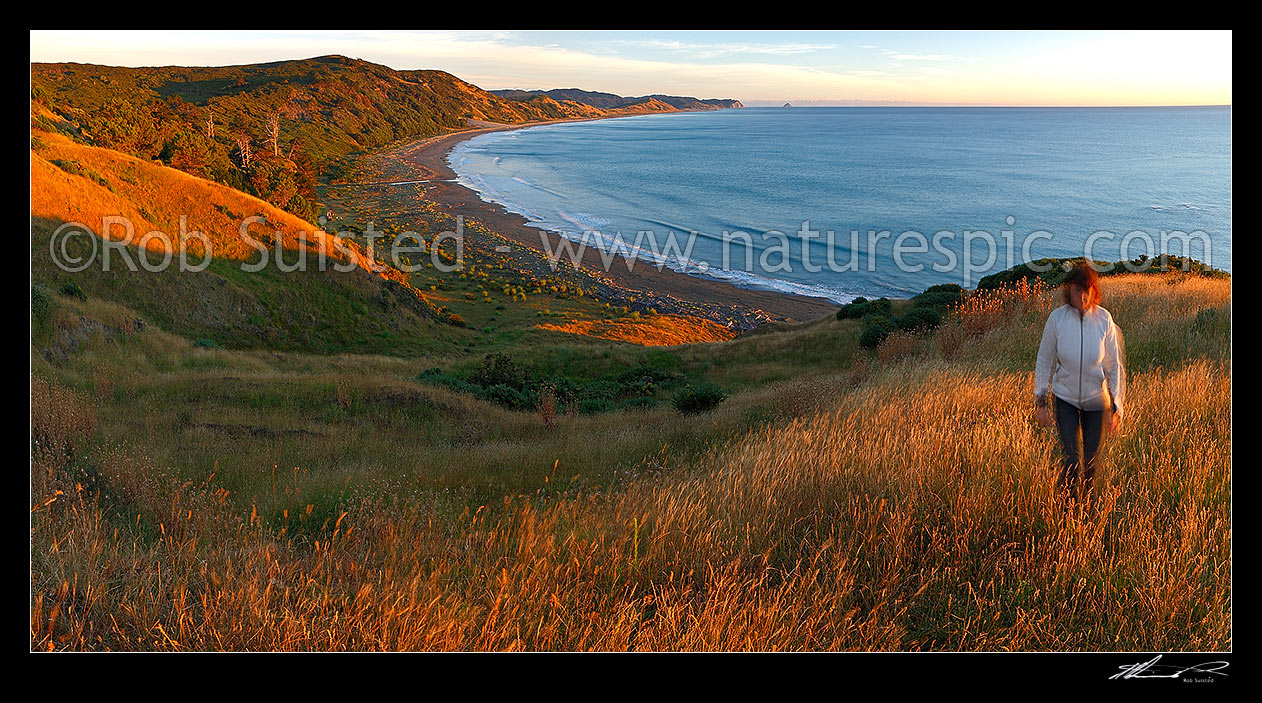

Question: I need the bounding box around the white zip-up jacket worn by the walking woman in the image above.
[1034,304,1126,414]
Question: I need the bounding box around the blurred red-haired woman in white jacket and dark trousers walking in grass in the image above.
[1034,260,1126,505]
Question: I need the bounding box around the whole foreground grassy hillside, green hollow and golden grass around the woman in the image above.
[32,274,1232,651]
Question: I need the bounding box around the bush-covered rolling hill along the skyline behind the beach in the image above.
[30,56,737,222]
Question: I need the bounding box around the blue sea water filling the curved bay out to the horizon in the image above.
[448,107,1232,302]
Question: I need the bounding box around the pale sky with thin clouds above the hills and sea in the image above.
[30,30,1232,105]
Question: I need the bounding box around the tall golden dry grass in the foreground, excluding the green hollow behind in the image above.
[32,271,1232,651]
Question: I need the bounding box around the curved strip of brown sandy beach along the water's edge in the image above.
[383,117,838,321]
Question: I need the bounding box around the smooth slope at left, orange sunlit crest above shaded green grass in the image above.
[30,133,474,357]
